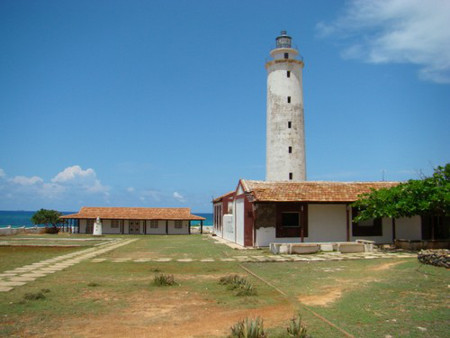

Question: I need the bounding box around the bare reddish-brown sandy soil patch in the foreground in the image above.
[27,290,294,337]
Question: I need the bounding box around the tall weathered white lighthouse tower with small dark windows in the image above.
[266,31,306,182]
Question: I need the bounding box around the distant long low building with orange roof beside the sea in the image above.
[61,207,205,235]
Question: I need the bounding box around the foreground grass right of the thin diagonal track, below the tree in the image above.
[246,259,450,337]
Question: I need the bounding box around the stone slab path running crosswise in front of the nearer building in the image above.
[92,252,417,263]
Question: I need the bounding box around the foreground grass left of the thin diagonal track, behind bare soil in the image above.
[0,248,283,336]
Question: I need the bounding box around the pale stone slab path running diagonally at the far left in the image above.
[0,239,137,292]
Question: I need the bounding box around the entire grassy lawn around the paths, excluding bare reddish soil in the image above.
[0,235,450,337]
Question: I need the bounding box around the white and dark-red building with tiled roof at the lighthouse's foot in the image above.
[213,180,449,247]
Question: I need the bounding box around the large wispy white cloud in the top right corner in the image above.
[316,0,450,83]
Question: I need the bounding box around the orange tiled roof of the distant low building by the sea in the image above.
[61,207,205,221]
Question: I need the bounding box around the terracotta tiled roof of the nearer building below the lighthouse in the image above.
[241,180,399,202]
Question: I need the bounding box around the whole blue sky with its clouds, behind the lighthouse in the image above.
[0,0,450,212]
